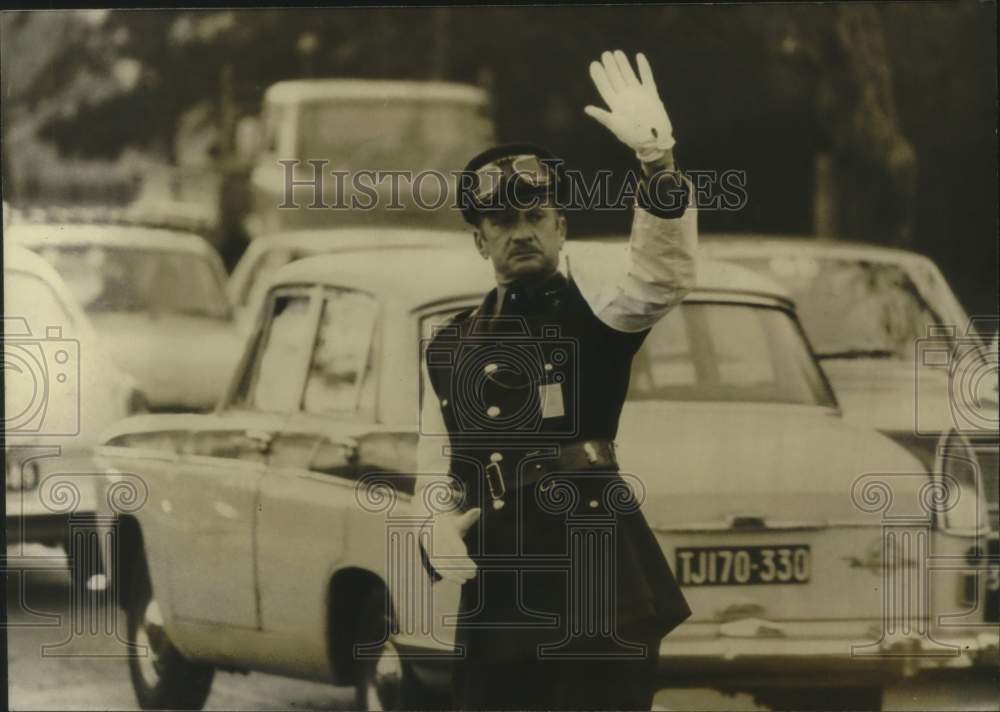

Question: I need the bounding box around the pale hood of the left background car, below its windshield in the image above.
[92,314,243,410]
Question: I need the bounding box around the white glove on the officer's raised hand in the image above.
[584,50,676,162]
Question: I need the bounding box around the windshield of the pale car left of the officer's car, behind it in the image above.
[38,245,231,320]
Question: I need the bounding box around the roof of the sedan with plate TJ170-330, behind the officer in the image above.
[270,241,791,306]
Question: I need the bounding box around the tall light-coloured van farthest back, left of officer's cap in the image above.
[237,79,495,235]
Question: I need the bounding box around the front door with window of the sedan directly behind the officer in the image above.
[163,288,317,628]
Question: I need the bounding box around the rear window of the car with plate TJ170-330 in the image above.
[628,302,834,405]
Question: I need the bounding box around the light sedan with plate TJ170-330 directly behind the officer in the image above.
[100,243,983,708]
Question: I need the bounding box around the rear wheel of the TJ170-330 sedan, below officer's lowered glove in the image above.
[352,589,452,710]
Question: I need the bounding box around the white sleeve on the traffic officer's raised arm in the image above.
[571,183,698,332]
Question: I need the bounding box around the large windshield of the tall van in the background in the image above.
[298,99,492,175]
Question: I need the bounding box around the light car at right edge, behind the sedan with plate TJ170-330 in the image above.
[700,235,998,439]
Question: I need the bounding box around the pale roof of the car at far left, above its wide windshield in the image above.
[5,223,213,255]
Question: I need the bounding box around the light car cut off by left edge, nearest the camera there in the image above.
[3,243,142,578]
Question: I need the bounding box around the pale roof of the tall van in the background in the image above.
[264,79,489,104]
